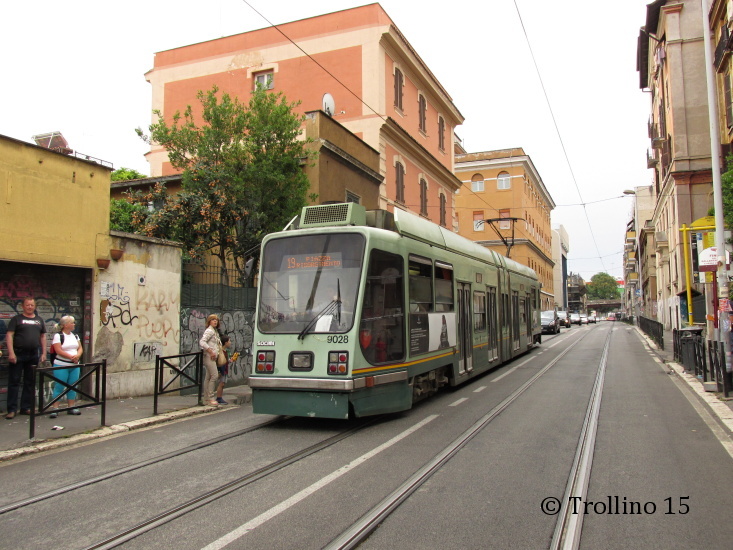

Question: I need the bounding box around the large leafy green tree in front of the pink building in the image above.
[135,86,310,284]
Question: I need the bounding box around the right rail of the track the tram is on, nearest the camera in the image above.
[84,416,382,550]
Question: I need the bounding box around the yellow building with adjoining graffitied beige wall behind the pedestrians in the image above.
[0,133,183,402]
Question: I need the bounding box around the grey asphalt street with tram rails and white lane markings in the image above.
[0,322,733,550]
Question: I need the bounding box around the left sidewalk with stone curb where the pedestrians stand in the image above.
[0,385,252,462]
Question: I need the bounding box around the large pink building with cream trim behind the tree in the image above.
[146,4,463,229]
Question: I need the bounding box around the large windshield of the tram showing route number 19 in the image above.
[258,233,364,337]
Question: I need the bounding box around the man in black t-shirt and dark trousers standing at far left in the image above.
[5,296,46,420]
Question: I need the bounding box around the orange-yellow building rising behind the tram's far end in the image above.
[455,147,555,310]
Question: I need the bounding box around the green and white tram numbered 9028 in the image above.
[249,203,541,418]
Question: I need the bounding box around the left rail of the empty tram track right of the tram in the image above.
[324,332,588,550]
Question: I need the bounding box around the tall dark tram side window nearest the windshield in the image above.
[359,250,405,364]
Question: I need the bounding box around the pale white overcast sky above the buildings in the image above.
[0,0,652,280]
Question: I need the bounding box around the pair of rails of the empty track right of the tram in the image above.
[324,326,596,550]
